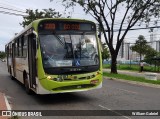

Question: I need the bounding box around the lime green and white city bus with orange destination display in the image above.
[5,18,103,94]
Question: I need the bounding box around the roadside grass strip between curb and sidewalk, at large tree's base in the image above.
[103,72,160,85]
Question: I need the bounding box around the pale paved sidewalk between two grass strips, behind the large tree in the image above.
[103,69,160,79]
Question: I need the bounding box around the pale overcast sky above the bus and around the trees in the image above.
[0,0,158,51]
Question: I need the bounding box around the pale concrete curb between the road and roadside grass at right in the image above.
[104,77,160,88]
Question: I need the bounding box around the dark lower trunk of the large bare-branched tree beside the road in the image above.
[111,54,117,74]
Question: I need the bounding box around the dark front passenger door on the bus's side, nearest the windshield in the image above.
[28,34,37,88]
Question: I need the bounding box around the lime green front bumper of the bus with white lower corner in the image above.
[37,75,102,94]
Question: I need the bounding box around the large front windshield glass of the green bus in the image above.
[39,34,99,68]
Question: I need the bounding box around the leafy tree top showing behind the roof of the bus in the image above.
[20,8,62,27]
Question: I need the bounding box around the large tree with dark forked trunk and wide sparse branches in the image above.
[60,0,160,73]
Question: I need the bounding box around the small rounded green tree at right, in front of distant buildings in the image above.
[131,35,151,62]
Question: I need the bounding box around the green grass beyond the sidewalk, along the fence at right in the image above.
[103,64,158,72]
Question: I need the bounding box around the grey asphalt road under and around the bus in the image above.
[0,62,160,119]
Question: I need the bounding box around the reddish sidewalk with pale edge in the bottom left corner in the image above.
[0,92,10,119]
